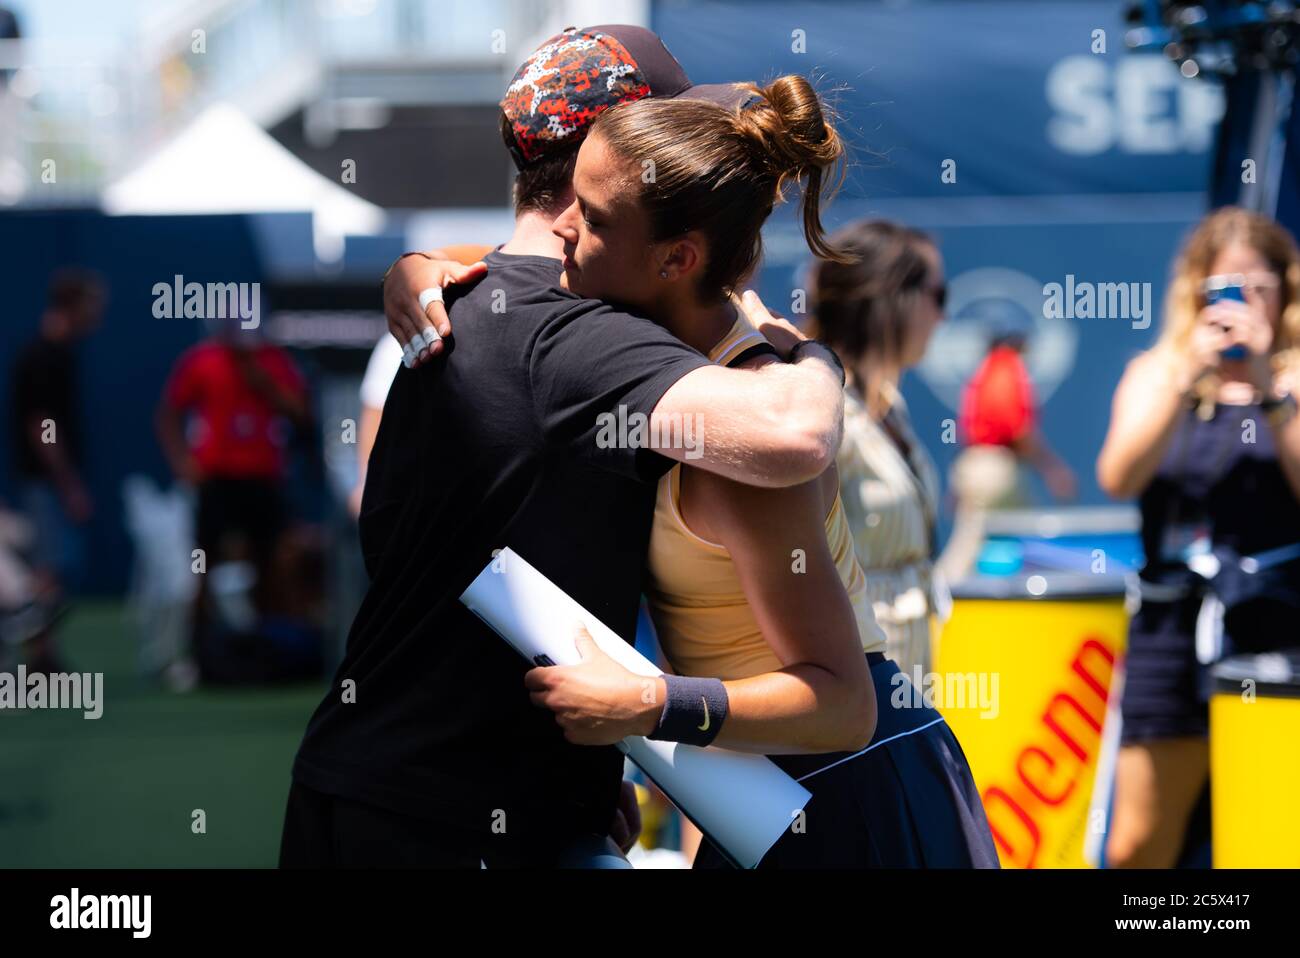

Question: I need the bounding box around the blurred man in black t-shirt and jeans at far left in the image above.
[12,269,105,672]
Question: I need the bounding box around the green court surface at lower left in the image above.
[0,603,325,868]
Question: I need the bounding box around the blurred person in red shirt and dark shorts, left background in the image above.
[157,320,311,679]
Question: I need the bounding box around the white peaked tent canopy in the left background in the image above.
[103,104,385,261]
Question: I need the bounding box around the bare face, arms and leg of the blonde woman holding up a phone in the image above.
[1097,243,1300,868]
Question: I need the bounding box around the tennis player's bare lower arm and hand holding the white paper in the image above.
[524,471,876,754]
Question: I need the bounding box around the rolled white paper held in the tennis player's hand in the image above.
[460,549,813,868]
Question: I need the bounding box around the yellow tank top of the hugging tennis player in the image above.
[646,317,885,679]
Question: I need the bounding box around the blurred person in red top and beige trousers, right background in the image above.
[937,317,1076,582]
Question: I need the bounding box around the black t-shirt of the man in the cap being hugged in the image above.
[294,252,707,832]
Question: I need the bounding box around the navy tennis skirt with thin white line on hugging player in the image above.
[694,653,998,868]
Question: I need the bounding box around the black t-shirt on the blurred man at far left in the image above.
[9,337,81,478]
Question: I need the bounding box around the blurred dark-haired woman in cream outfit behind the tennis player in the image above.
[813,220,946,676]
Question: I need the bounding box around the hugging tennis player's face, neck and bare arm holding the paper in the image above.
[525,131,876,754]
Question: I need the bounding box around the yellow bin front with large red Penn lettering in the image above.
[935,594,1127,868]
